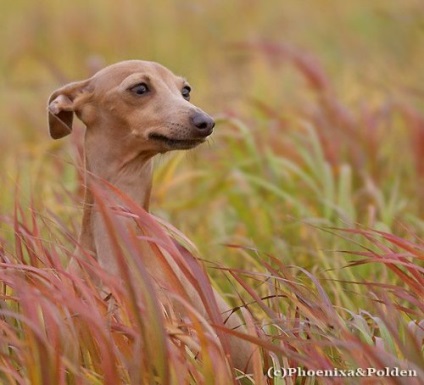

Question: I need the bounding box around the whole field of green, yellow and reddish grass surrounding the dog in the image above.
[0,0,424,385]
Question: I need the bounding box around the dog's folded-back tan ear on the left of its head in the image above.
[47,80,88,139]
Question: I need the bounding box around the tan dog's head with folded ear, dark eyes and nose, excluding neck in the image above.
[48,60,215,154]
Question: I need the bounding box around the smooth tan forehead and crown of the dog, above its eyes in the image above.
[92,60,184,88]
